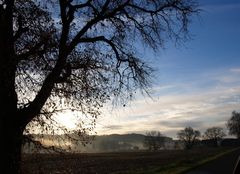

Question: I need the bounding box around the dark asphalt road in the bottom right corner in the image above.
[187,149,240,174]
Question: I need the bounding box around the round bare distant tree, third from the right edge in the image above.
[177,127,201,149]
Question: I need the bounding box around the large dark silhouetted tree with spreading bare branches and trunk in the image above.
[0,0,197,173]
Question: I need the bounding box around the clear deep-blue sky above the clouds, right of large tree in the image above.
[159,0,240,84]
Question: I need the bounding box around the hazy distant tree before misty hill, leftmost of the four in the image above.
[144,131,165,151]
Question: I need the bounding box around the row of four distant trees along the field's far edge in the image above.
[144,111,240,151]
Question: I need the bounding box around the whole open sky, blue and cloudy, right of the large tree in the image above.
[90,0,240,138]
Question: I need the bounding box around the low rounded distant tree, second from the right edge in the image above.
[203,127,226,146]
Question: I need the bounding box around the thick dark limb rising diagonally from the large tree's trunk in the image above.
[20,0,82,124]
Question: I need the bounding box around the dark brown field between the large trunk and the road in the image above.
[22,148,234,174]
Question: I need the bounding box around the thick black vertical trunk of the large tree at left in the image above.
[0,3,24,174]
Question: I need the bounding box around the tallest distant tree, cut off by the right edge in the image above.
[227,111,240,139]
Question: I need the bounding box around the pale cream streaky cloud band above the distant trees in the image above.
[98,68,240,138]
